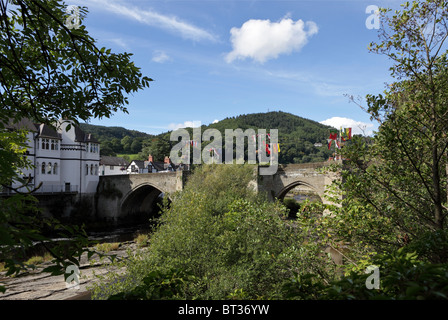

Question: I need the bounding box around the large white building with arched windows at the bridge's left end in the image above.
[4,119,100,194]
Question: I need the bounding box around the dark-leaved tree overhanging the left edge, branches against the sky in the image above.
[0,0,151,284]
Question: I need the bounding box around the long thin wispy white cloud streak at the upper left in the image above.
[89,0,216,41]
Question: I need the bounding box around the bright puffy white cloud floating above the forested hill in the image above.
[225,17,318,63]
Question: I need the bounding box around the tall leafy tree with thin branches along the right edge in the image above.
[343,0,448,252]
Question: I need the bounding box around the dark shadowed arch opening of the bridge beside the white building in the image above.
[118,183,166,224]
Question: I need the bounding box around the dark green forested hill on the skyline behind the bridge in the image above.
[81,111,333,163]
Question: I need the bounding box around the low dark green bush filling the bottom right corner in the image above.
[283,249,448,300]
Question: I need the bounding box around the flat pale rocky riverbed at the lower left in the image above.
[0,241,139,300]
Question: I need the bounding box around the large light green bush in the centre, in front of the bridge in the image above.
[91,165,333,299]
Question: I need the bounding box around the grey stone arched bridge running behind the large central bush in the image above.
[96,162,336,224]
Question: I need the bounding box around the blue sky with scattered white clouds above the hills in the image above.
[72,0,401,134]
